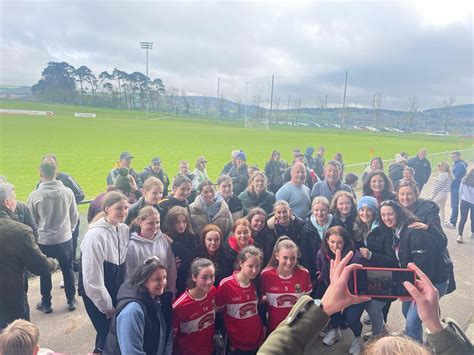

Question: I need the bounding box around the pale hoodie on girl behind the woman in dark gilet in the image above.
[125,231,177,293]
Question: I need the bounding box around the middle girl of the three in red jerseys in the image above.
[216,246,264,355]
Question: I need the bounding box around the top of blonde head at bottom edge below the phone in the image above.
[363,336,431,355]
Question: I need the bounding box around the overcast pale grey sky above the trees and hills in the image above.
[0,0,474,109]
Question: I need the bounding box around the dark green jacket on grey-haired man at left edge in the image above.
[0,208,57,329]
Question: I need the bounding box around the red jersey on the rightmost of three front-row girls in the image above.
[260,267,313,333]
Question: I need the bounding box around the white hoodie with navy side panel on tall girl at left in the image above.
[81,218,129,313]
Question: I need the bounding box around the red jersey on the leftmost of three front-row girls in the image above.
[173,286,217,355]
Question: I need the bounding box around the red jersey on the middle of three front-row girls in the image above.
[216,272,263,350]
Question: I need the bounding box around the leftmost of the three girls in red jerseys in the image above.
[173,258,216,355]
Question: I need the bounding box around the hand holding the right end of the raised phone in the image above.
[403,263,443,333]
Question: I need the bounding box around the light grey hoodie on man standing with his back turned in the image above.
[28,180,79,245]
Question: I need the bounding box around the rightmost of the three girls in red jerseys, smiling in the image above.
[260,237,313,334]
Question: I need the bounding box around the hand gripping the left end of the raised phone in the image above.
[321,250,370,316]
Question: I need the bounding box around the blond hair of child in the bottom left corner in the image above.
[0,319,39,355]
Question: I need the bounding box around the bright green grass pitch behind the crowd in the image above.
[0,101,472,201]
